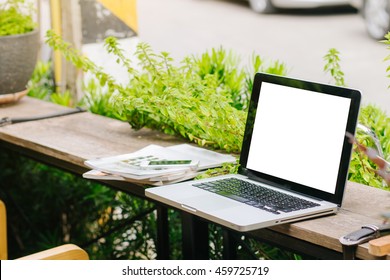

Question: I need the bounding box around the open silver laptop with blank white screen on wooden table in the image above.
[145,73,361,231]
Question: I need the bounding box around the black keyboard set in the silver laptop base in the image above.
[193,178,320,214]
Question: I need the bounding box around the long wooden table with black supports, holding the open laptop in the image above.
[0,97,390,259]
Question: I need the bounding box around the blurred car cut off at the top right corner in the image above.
[351,0,390,40]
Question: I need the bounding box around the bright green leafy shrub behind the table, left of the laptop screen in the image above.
[47,31,285,152]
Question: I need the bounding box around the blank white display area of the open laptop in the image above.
[246,82,351,194]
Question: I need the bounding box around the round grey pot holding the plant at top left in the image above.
[0,29,39,94]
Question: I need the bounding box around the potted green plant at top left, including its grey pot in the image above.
[0,0,39,99]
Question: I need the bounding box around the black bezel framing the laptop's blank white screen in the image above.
[239,73,361,206]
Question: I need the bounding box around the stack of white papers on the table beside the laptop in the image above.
[83,144,236,186]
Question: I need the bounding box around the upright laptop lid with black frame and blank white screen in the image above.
[240,73,361,205]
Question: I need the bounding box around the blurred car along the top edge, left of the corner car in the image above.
[248,0,350,14]
